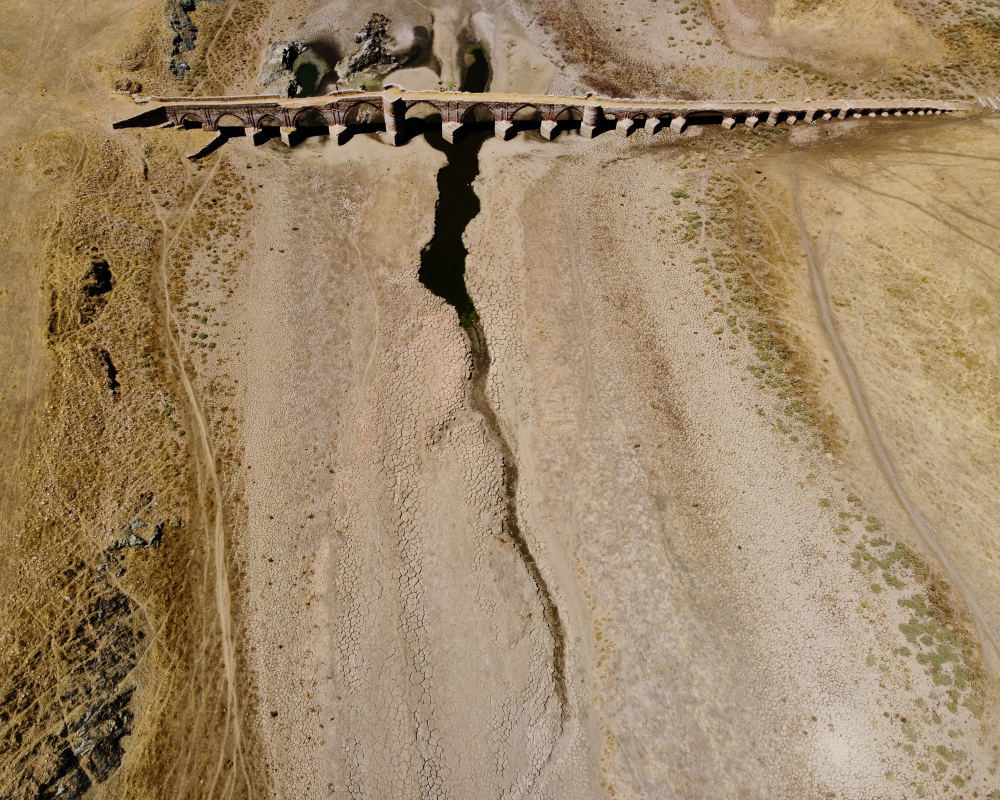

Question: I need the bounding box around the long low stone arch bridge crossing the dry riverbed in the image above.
[114,85,1000,145]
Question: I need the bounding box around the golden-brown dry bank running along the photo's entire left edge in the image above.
[0,2,312,798]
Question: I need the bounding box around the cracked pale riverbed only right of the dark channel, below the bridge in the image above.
[470,126,994,797]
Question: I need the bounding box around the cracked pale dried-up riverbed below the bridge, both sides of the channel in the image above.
[189,117,994,797]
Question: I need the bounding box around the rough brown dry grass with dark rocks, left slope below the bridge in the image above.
[0,120,266,798]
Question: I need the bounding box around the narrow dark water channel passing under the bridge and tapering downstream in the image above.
[419,44,569,722]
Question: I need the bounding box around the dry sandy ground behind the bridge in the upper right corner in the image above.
[522,0,1000,98]
